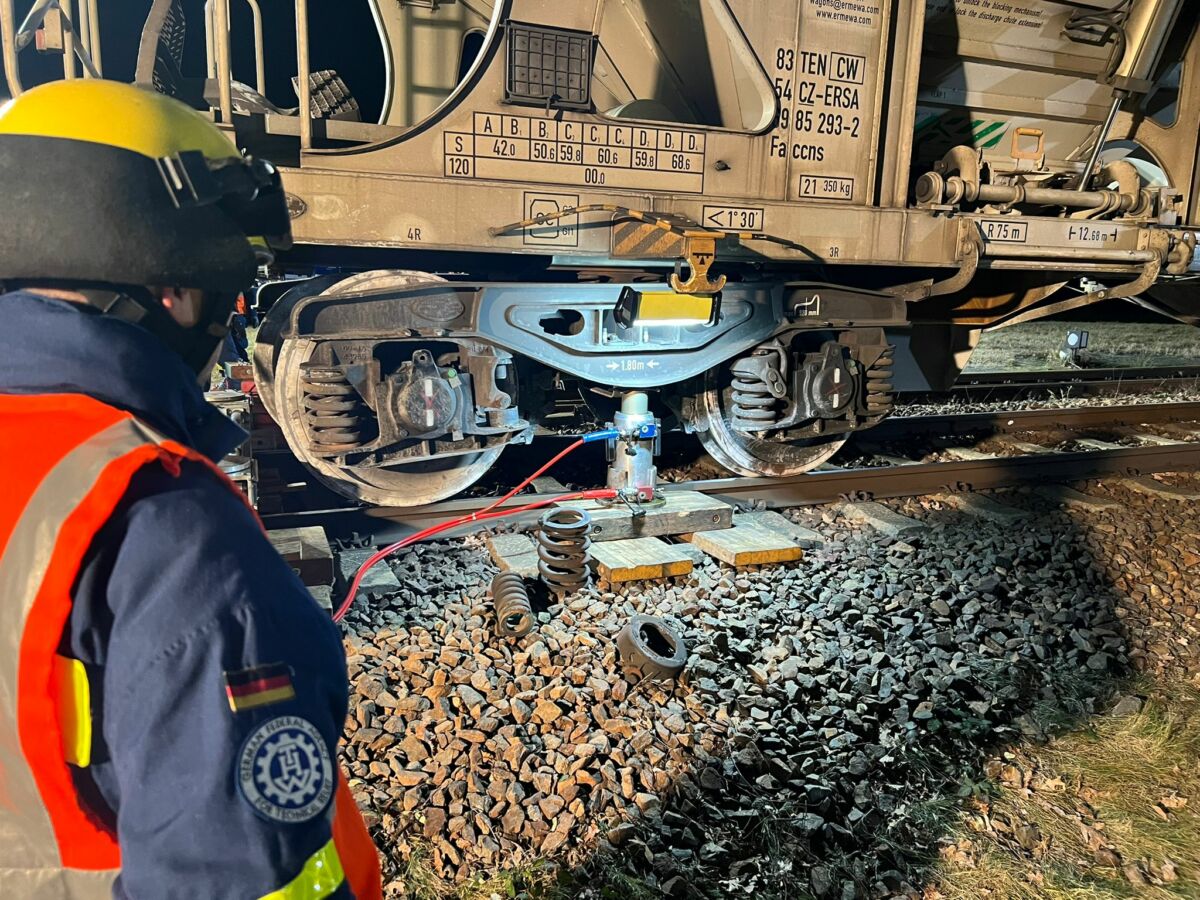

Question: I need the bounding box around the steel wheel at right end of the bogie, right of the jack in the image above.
[696,378,846,478]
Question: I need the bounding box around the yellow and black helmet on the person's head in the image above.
[0,79,290,292]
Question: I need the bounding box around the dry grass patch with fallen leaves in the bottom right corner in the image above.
[931,685,1200,900]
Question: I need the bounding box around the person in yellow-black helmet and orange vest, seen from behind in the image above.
[0,79,380,900]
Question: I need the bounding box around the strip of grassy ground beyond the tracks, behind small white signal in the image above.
[966,322,1200,372]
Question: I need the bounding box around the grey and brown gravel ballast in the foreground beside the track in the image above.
[344,481,1200,898]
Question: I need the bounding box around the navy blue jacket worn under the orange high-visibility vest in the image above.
[0,292,350,900]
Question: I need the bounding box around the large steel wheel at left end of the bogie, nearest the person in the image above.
[269,270,504,506]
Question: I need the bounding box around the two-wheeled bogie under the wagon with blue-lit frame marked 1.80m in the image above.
[259,271,904,505]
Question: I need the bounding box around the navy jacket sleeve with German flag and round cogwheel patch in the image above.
[92,463,378,900]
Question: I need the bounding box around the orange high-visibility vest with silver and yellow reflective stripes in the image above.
[0,394,382,900]
